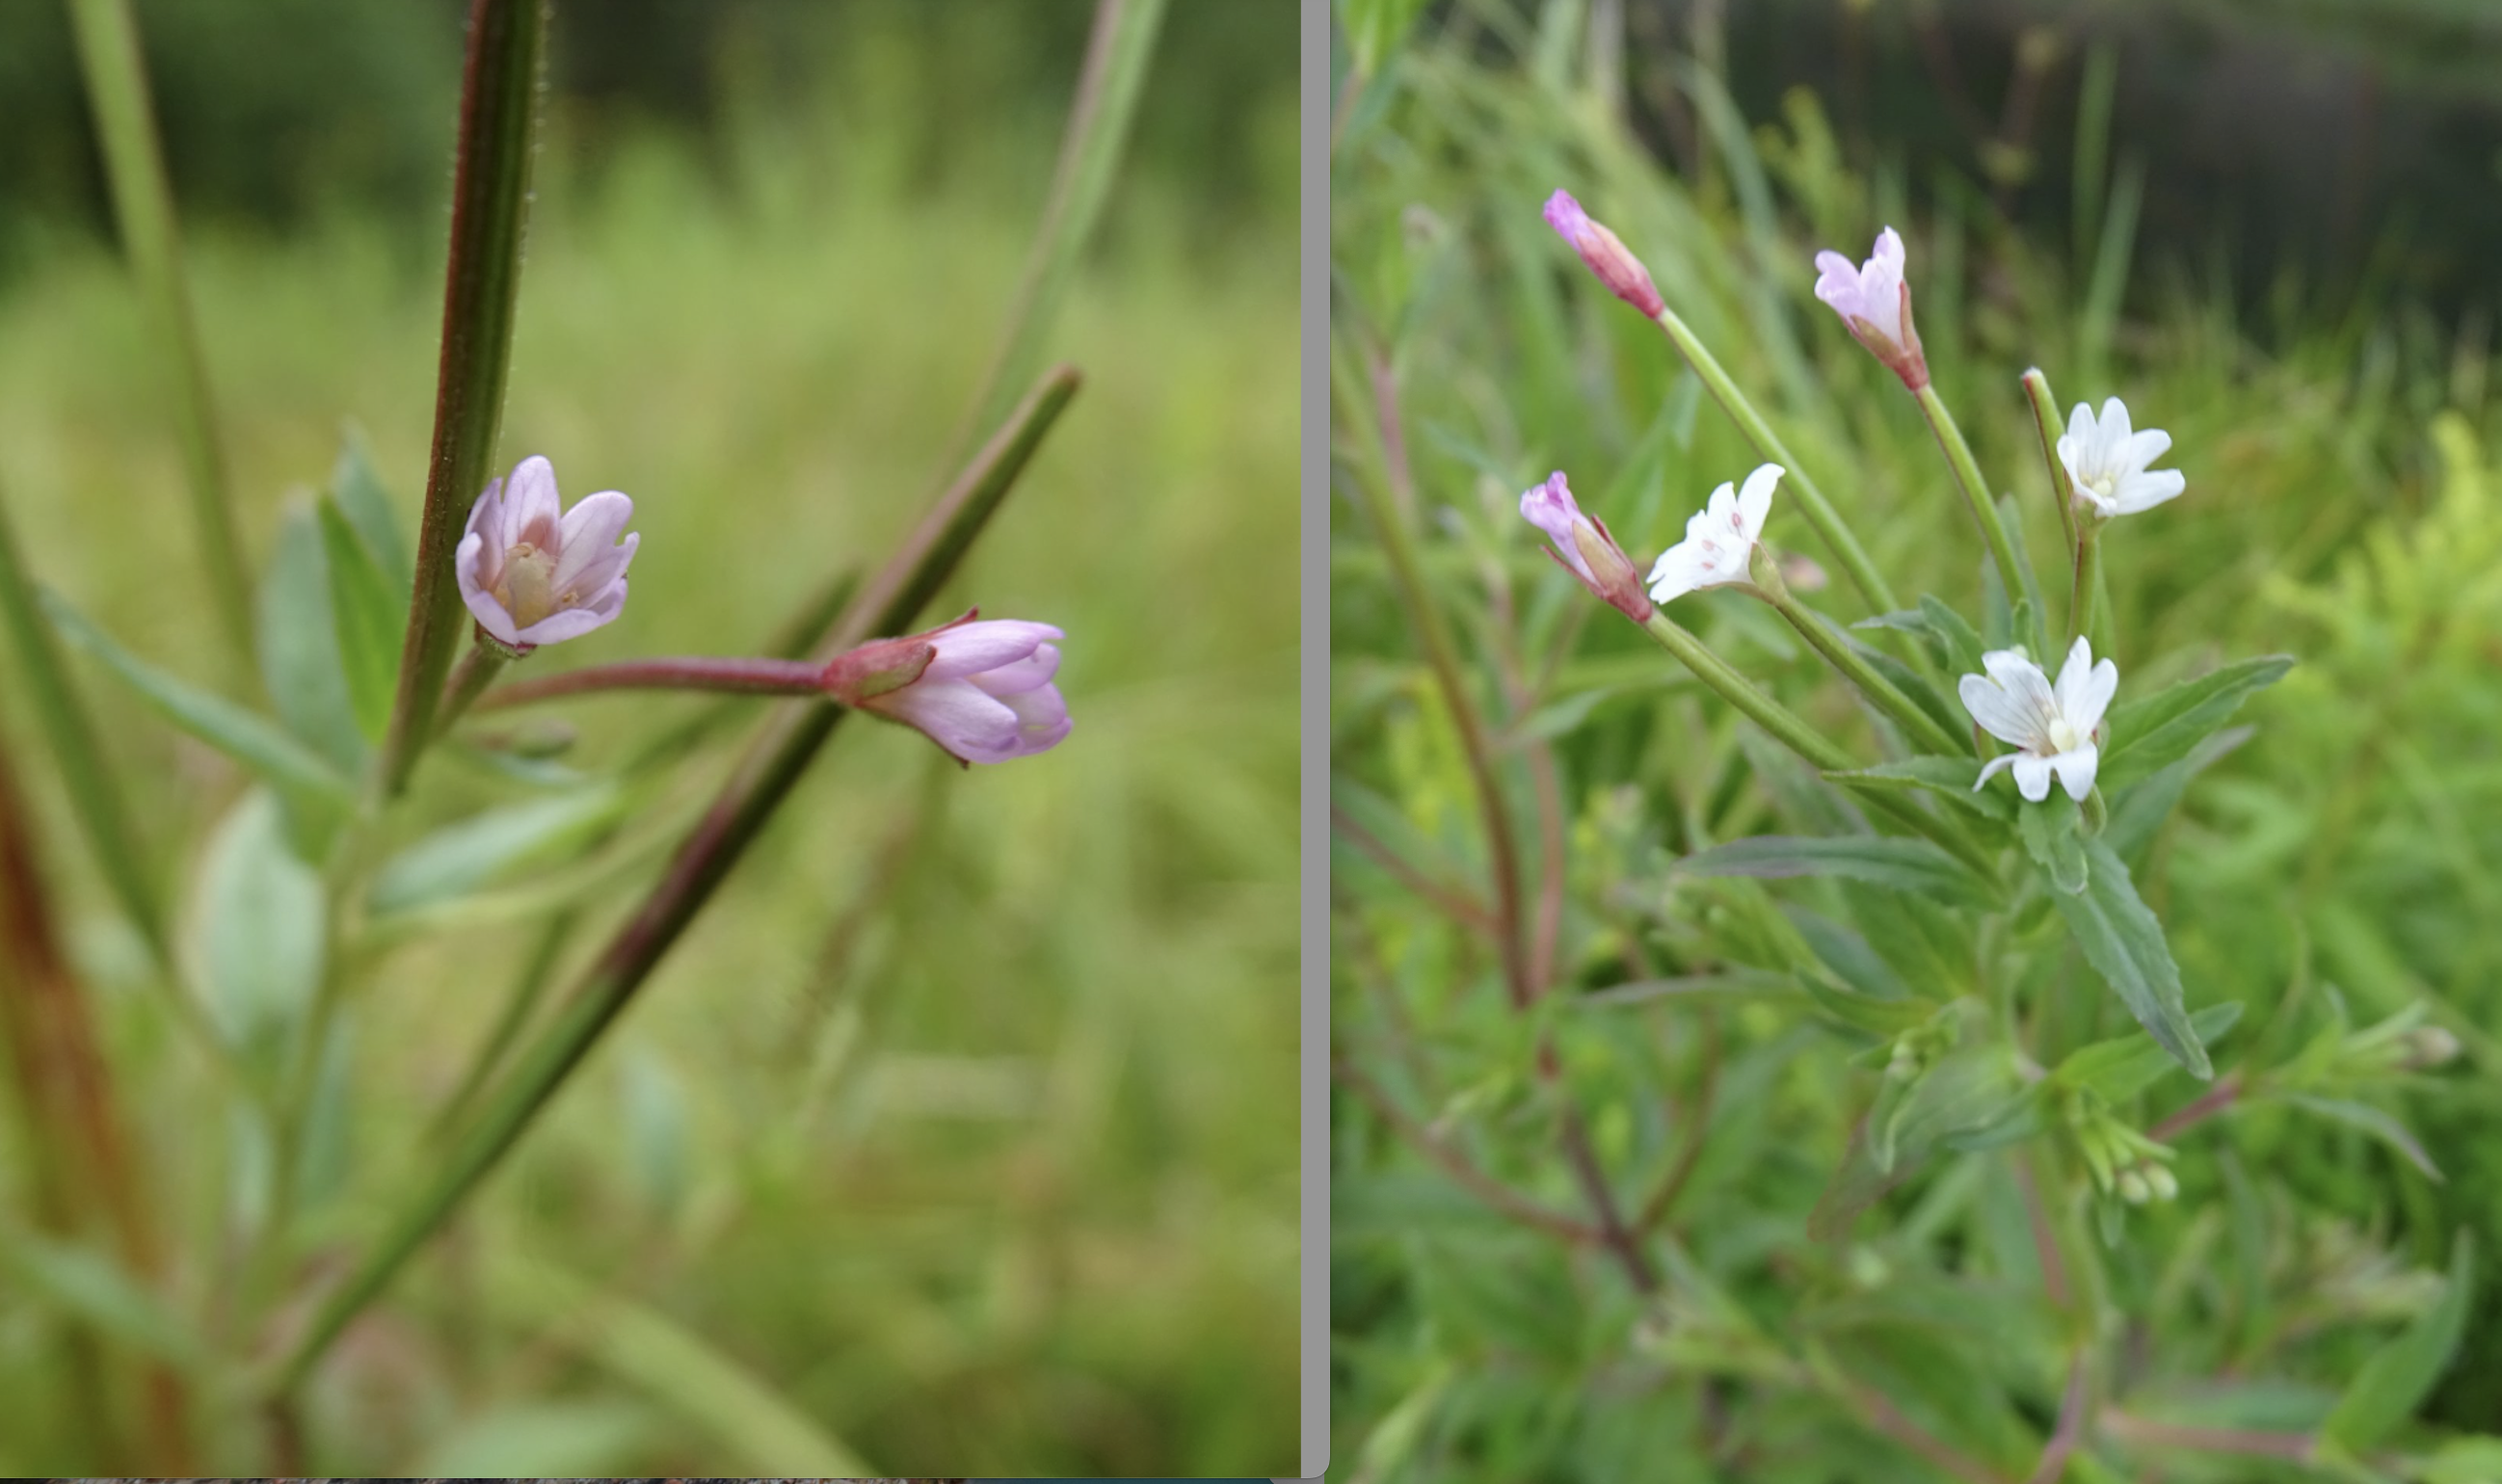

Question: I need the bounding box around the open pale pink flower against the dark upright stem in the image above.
[453,453,643,650]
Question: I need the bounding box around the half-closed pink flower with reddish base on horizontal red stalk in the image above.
[820,608,1071,763]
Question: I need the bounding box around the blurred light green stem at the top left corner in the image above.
[70,0,253,674]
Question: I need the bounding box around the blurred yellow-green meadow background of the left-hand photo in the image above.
[0,0,1298,1474]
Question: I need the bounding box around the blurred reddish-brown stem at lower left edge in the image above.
[0,735,190,1474]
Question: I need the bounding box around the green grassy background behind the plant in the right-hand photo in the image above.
[1331,0,2502,1484]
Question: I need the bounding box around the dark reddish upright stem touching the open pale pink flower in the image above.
[381,0,548,796]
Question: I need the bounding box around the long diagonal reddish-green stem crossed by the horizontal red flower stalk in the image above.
[268,368,1078,1396]
